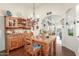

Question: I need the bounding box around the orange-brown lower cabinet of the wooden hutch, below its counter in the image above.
[8,35,24,51]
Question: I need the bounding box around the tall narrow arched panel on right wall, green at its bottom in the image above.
[66,9,75,36]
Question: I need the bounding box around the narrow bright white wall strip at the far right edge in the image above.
[76,4,79,56]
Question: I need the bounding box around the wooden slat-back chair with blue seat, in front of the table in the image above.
[24,34,41,56]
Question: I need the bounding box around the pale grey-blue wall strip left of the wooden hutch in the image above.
[0,16,5,51]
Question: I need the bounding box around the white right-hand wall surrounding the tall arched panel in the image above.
[62,6,78,52]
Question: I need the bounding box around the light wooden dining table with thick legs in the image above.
[32,35,56,56]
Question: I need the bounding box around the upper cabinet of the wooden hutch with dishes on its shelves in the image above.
[5,16,32,29]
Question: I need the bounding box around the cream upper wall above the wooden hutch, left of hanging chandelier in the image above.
[0,3,33,18]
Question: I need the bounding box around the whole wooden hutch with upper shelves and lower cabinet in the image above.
[4,16,32,53]
